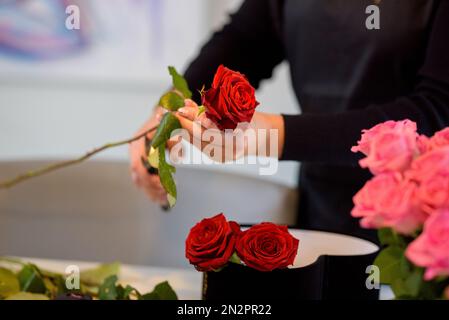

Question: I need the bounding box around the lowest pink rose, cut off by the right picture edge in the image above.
[405,209,449,280]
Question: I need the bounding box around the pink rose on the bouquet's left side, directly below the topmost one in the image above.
[351,173,427,234]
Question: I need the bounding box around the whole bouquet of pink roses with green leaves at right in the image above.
[352,120,449,299]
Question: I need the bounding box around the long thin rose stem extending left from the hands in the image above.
[0,126,157,189]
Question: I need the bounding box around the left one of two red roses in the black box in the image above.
[186,213,240,271]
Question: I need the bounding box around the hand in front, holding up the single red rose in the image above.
[177,100,284,162]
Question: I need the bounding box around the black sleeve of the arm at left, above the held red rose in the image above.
[184,0,285,102]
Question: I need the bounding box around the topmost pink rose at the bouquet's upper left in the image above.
[351,120,419,174]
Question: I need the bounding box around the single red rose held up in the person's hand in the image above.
[202,65,259,130]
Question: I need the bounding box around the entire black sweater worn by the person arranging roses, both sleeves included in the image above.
[185,0,449,237]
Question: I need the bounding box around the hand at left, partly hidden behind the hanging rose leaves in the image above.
[129,107,167,205]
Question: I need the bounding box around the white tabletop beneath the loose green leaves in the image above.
[3,258,393,300]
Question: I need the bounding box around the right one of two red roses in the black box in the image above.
[235,222,299,271]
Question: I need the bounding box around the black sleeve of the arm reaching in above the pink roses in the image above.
[282,1,449,165]
